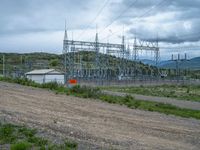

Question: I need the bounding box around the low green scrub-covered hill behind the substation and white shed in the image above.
[0,52,157,77]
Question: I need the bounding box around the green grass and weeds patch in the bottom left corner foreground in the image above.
[0,123,77,150]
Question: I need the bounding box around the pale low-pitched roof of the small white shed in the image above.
[26,69,63,75]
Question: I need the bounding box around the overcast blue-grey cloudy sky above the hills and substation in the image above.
[0,0,200,59]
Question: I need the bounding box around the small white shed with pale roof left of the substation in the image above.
[25,69,64,84]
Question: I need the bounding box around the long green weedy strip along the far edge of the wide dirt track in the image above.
[0,77,200,119]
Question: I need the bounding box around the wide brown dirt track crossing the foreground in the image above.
[0,82,200,150]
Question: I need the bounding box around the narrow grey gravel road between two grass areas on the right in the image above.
[103,90,200,110]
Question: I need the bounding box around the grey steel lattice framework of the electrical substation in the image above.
[63,30,159,80]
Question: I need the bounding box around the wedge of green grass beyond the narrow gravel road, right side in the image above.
[103,85,200,102]
